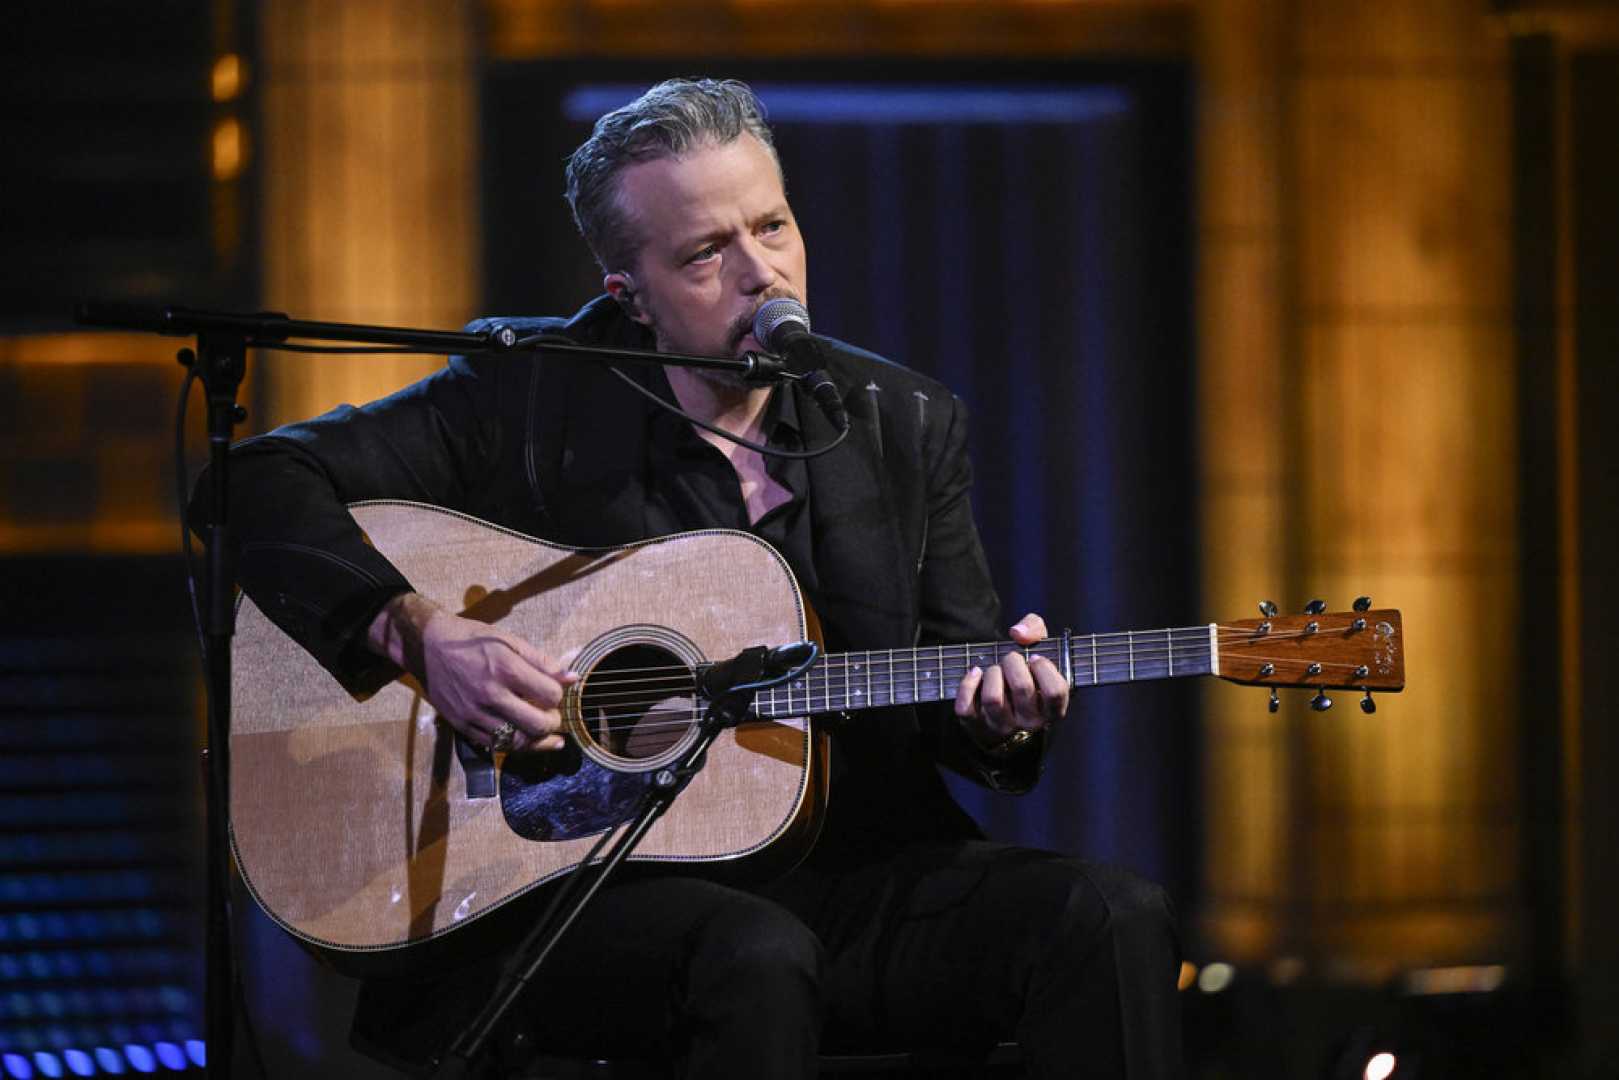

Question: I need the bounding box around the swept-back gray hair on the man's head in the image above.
[567,79,782,274]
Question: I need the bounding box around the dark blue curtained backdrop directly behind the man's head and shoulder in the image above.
[482,62,1204,900]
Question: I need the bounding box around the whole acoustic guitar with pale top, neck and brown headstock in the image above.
[230,502,1405,967]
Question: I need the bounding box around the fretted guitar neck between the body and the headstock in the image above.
[753,625,1216,719]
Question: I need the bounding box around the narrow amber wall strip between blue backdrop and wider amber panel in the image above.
[1196,0,1292,960]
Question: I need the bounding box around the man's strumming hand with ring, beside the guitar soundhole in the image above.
[366,593,580,750]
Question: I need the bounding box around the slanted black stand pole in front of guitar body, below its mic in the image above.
[432,687,756,1080]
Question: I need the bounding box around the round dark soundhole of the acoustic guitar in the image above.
[580,644,698,761]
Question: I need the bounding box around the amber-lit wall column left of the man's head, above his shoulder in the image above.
[257,0,479,427]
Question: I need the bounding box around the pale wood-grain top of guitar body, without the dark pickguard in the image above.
[230,502,826,959]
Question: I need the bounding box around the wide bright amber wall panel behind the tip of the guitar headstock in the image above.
[1287,0,1520,970]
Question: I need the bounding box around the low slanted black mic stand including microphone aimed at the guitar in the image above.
[432,641,821,1078]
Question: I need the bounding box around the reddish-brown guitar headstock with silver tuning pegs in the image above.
[1214,601,1405,699]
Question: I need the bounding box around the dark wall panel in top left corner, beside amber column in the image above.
[0,0,256,330]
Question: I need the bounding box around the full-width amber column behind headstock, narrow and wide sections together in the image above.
[1201,0,1520,980]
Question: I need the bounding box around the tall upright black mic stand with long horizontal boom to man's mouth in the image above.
[74,301,806,1078]
